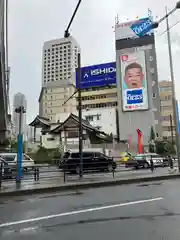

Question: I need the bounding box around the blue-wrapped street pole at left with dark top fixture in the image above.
[15,106,26,183]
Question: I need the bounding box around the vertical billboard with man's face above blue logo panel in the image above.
[120,50,149,112]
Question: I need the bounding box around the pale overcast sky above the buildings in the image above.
[9,0,180,122]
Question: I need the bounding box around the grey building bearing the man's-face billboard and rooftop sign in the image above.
[115,17,162,145]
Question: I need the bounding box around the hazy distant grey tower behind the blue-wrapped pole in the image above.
[13,93,27,136]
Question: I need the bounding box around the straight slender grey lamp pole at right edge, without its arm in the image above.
[166,7,180,172]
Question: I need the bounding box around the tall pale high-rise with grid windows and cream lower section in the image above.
[39,36,80,121]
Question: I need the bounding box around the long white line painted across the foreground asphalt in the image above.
[0,197,163,228]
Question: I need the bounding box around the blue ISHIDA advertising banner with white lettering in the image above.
[76,62,116,89]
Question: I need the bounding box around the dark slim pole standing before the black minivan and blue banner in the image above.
[77,53,83,178]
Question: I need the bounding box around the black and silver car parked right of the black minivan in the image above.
[125,153,169,169]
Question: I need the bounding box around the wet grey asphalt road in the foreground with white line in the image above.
[0,180,180,240]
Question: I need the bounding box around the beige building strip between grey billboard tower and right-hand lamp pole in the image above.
[159,81,175,138]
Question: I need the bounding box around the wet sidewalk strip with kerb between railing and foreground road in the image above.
[0,168,180,196]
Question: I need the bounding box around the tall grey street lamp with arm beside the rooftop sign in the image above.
[151,1,180,172]
